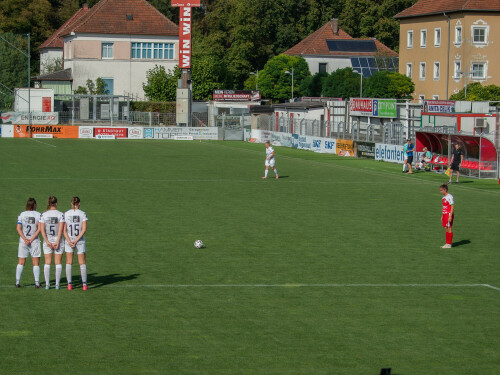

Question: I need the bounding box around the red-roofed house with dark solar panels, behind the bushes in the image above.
[285,18,399,78]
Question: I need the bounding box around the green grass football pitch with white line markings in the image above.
[0,139,500,375]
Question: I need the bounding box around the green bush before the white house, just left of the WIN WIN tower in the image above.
[142,65,181,102]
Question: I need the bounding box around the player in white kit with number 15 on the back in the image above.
[64,197,87,290]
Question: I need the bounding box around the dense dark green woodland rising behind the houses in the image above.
[0,0,416,97]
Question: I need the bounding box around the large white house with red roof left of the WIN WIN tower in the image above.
[36,0,179,98]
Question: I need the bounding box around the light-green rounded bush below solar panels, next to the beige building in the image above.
[363,71,415,99]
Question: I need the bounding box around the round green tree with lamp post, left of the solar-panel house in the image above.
[258,54,311,101]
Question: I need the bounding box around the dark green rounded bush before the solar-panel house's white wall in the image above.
[323,68,366,99]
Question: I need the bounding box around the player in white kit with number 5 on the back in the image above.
[40,196,64,290]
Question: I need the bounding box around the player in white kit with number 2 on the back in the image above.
[15,198,41,288]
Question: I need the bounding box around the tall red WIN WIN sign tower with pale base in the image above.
[172,0,201,126]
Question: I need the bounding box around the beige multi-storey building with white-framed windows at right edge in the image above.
[395,0,500,100]
